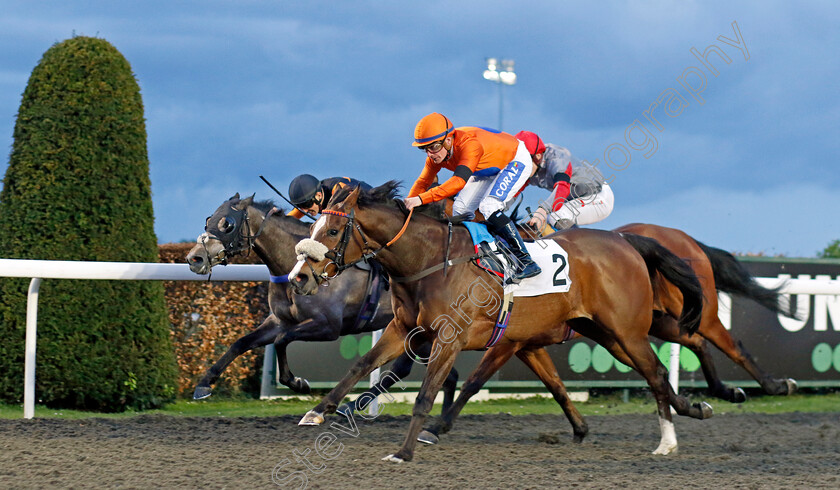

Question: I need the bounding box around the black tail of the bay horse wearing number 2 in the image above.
[621,233,703,335]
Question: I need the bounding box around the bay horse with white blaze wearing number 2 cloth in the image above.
[290,181,711,462]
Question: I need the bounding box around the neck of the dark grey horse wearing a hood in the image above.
[249,208,306,275]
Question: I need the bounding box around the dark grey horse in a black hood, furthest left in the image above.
[187,193,458,402]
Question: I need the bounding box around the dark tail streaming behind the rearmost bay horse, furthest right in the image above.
[694,240,796,318]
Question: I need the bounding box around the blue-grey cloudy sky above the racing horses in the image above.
[0,0,840,257]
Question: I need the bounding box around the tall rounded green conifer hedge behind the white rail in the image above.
[0,36,176,411]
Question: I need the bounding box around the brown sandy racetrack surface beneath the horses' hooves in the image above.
[0,413,840,489]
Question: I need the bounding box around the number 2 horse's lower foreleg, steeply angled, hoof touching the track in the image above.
[382,340,461,463]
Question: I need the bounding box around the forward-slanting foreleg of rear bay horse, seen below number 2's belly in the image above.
[419,343,522,444]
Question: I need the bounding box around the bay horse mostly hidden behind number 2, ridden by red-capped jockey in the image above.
[418,223,796,444]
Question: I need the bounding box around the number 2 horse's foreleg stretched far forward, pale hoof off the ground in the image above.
[298,320,405,425]
